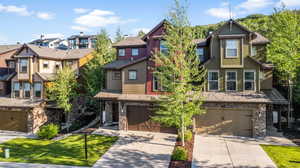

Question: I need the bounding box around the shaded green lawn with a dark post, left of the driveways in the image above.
[0,135,118,166]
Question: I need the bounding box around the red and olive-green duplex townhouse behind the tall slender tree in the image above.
[95,20,287,137]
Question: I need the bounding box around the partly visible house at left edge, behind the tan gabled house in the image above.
[0,44,22,96]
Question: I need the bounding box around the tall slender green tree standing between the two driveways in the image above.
[153,0,206,146]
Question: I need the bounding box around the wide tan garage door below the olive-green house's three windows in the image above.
[195,109,253,137]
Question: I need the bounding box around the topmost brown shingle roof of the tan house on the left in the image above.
[16,44,93,60]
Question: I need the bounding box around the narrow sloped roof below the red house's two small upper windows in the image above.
[103,57,148,70]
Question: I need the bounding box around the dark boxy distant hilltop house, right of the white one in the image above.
[68,32,96,49]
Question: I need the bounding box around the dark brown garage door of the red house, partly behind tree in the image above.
[127,105,176,133]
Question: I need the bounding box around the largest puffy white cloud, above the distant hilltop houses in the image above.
[74,9,136,28]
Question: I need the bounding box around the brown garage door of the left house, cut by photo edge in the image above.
[0,111,27,132]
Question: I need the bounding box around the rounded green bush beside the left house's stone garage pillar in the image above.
[37,124,59,139]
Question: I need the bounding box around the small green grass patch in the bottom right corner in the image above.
[261,145,300,168]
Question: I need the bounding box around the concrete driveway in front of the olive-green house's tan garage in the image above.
[192,135,294,168]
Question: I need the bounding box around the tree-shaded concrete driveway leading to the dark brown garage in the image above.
[93,129,176,168]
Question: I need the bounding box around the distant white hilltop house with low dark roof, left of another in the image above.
[28,35,68,50]
